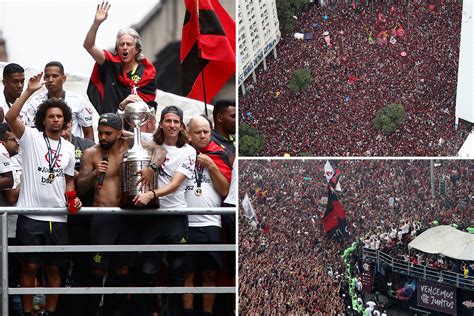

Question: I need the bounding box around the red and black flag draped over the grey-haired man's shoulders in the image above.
[87,50,156,115]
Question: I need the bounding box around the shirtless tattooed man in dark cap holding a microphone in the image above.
[77,113,131,315]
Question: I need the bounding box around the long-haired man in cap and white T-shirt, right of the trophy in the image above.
[134,106,196,315]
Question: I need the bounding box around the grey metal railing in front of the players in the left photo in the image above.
[0,207,236,315]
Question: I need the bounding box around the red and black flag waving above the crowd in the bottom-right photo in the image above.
[322,189,347,238]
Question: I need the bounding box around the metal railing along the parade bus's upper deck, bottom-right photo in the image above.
[362,248,474,291]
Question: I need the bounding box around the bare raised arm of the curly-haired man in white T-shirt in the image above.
[5,72,44,139]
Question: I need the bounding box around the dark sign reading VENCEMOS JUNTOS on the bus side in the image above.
[416,280,456,315]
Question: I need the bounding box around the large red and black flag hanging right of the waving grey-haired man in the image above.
[180,0,235,101]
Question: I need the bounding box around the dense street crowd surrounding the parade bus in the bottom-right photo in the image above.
[239,160,474,315]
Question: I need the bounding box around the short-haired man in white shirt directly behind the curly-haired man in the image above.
[21,61,94,141]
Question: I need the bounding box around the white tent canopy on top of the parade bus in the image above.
[408,225,474,261]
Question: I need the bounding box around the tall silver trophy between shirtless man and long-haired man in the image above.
[120,102,159,208]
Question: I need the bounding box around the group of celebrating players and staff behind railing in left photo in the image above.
[0,1,237,316]
